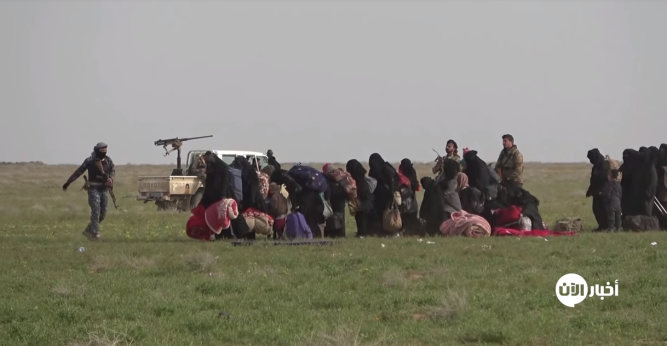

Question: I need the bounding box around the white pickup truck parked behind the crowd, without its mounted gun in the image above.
[137,150,269,211]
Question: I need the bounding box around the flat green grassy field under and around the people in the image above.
[0,164,667,346]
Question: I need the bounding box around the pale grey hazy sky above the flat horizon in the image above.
[0,0,667,164]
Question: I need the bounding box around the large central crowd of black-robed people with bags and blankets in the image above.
[186,143,560,241]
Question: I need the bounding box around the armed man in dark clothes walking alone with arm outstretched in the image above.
[63,142,116,240]
